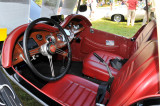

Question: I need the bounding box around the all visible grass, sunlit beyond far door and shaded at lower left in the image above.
[12,19,142,106]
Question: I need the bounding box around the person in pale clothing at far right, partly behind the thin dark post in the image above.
[142,0,155,25]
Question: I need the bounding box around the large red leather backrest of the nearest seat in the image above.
[108,41,158,106]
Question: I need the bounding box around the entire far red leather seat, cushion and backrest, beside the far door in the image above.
[82,21,156,81]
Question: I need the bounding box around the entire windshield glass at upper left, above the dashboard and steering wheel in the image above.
[0,0,78,33]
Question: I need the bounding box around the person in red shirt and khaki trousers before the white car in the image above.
[126,0,138,26]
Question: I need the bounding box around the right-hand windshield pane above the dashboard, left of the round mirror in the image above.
[41,0,77,17]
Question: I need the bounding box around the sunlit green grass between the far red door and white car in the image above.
[92,18,142,37]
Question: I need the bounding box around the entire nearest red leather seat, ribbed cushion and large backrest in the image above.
[42,41,159,106]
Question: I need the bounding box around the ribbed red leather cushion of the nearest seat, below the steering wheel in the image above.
[42,74,109,106]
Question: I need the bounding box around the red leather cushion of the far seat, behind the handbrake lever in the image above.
[82,51,123,81]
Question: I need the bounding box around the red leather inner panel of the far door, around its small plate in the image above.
[81,29,131,58]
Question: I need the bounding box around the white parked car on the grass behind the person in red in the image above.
[105,5,145,22]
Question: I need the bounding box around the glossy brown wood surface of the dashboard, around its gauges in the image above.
[12,21,85,65]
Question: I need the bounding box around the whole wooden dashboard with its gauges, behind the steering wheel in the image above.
[12,20,85,65]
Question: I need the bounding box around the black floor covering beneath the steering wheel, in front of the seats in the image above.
[17,61,102,88]
